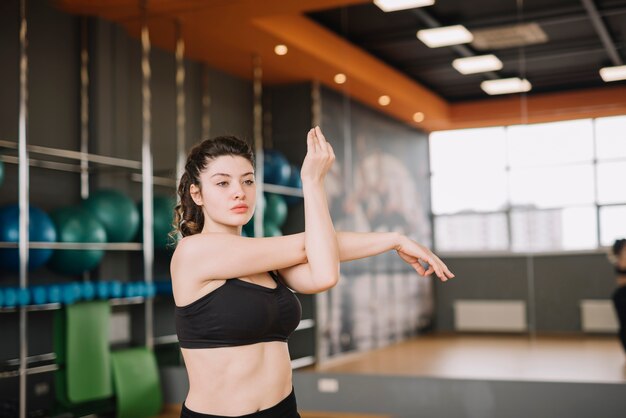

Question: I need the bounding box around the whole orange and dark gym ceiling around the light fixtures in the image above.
[53,0,626,131]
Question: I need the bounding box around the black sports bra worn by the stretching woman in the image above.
[175,272,302,348]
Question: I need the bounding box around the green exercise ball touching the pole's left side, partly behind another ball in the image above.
[83,189,139,242]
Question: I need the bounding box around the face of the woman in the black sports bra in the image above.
[191,155,256,230]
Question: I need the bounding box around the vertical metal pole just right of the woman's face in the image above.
[252,55,265,237]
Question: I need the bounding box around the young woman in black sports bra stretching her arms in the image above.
[170,127,453,418]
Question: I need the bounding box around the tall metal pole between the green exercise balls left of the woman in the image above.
[141,18,154,349]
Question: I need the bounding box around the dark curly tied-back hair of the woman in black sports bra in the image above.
[170,136,254,238]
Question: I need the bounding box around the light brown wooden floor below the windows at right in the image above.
[300,335,626,383]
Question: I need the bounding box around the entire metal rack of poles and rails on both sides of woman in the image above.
[0,0,315,418]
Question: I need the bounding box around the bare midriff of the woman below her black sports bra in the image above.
[182,341,292,416]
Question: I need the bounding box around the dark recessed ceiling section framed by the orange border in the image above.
[308,0,626,102]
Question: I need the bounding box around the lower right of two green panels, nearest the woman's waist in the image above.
[111,347,163,418]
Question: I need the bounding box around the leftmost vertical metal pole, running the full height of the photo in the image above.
[18,0,29,418]
